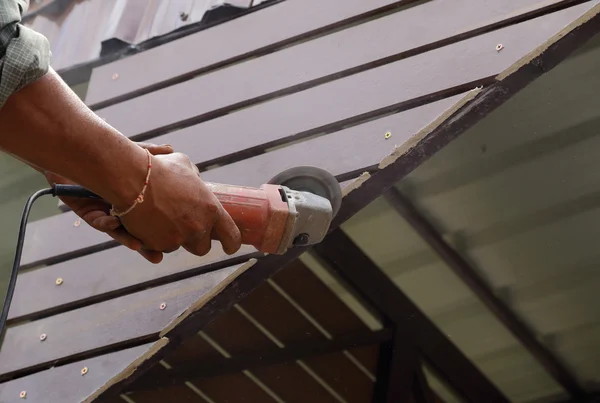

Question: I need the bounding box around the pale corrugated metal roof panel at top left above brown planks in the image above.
[24,0,252,70]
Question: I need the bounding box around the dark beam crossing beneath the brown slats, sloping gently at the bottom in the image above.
[128,329,392,390]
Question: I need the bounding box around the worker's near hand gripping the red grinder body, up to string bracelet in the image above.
[120,153,241,256]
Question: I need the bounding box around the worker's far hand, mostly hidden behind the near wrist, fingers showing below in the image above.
[45,143,173,263]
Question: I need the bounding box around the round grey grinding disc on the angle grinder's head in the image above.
[269,166,342,217]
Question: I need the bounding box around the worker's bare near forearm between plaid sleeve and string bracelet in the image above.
[0,70,147,209]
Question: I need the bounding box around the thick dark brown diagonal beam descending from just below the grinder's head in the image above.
[315,229,508,403]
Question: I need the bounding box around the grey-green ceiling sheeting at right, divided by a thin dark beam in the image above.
[332,29,600,402]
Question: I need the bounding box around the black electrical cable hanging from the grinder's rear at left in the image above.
[0,185,99,345]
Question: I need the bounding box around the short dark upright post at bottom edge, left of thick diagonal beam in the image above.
[373,329,419,403]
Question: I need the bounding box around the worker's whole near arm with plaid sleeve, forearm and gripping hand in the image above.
[0,0,241,255]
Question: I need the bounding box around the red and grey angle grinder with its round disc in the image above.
[53,166,342,255]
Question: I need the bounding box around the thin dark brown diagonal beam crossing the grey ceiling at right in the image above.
[385,187,585,398]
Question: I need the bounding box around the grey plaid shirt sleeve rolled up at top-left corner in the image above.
[0,0,51,108]
